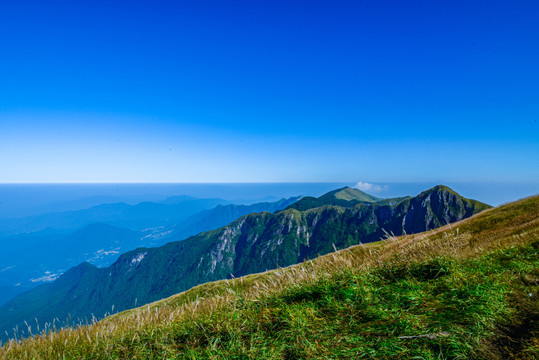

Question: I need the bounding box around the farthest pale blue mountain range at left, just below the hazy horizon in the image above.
[0,197,230,236]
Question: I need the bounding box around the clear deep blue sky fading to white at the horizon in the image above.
[0,0,539,183]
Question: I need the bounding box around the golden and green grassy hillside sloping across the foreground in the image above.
[0,196,539,359]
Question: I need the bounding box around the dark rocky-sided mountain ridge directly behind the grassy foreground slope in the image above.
[0,186,490,338]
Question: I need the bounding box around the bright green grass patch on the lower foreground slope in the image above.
[86,242,539,359]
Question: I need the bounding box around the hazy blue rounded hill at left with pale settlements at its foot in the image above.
[0,224,141,304]
